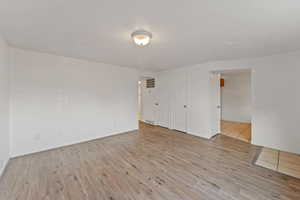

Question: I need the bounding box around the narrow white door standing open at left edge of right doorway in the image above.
[209,73,221,136]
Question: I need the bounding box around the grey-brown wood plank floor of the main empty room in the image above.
[0,124,300,200]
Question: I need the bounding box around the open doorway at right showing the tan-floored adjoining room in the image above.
[220,71,251,143]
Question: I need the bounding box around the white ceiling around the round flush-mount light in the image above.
[0,0,300,71]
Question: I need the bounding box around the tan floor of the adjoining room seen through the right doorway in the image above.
[221,120,251,142]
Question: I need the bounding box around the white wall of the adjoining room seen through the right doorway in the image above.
[221,72,251,123]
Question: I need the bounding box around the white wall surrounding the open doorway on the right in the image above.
[158,52,300,153]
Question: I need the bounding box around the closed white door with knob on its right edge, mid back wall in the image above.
[170,70,187,132]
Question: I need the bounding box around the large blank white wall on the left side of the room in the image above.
[11,48,139,156]
